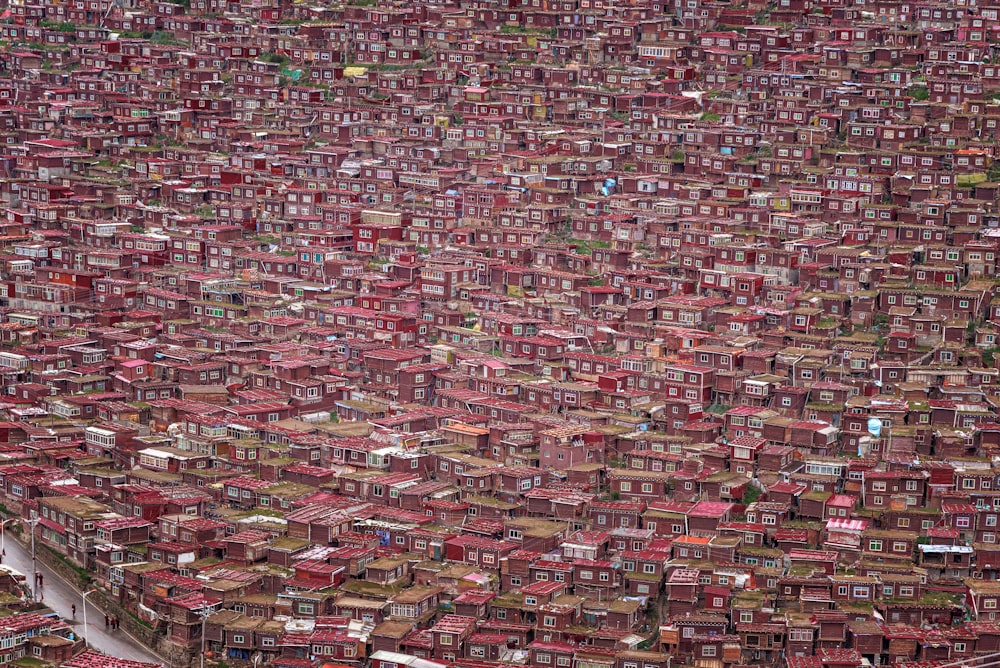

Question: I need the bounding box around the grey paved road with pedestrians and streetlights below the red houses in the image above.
[3,527,162,663]
